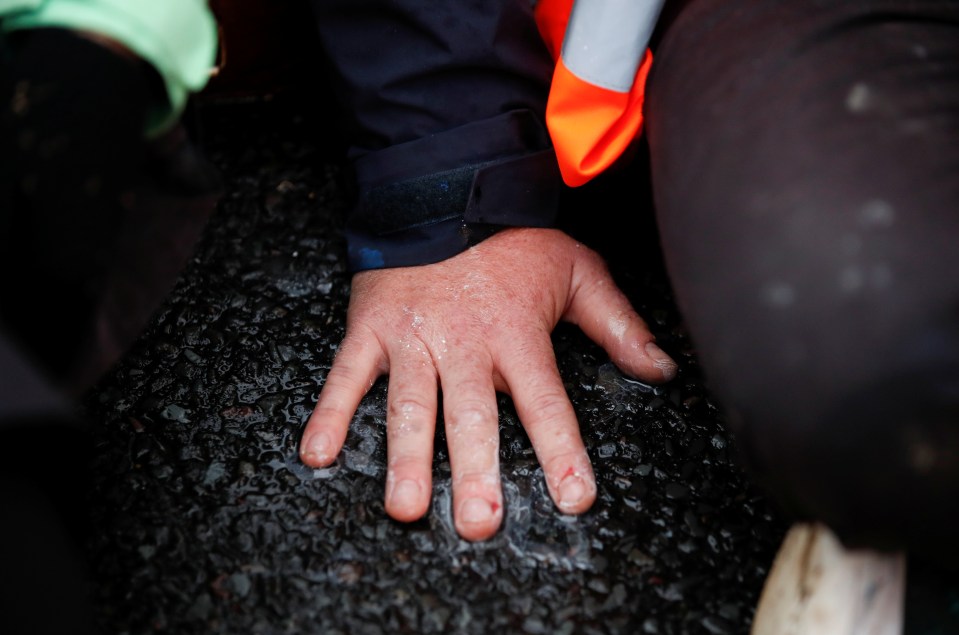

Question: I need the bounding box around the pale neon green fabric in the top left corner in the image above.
[0,0,217,136]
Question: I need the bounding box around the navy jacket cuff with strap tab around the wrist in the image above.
[346,110,562,272]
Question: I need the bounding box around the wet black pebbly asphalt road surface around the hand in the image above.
[84,93,956,635]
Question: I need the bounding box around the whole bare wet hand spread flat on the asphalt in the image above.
[300,228,676,540]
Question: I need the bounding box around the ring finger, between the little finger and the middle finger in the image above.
[385,346,438,522]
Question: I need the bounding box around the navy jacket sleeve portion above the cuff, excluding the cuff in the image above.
[312,0,553,159]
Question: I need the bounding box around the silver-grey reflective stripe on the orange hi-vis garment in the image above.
[562,0,664,93]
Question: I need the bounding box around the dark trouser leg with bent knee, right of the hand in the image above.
[647,0,959,562]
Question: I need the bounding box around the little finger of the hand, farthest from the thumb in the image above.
[300,333,385,467]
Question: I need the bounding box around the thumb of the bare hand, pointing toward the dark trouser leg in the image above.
[566,262,678,383]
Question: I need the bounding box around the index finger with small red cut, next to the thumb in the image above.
[501,336,596,514]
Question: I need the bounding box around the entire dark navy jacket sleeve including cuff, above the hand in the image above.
[314,0,562,271]
